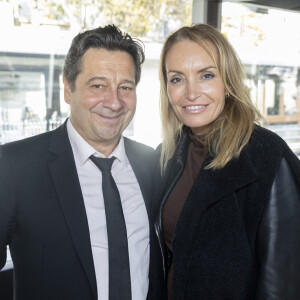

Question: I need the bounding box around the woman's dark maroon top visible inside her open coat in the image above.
[162,134,206,300]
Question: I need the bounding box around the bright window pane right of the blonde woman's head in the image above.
[222,2,300,124]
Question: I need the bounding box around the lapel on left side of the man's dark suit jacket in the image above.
[49,123,97,299]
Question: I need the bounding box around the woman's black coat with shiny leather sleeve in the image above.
[150,127,300,300]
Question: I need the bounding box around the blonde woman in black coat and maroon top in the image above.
[150,24,300,300]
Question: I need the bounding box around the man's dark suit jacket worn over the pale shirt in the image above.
[0,123,153,300]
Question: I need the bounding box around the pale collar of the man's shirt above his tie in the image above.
[67,119,129,166]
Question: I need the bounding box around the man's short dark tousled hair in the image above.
[63,25,145,91]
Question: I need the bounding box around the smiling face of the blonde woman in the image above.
[165,40,225,135]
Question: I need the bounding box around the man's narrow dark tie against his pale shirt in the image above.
[90,156,131,300]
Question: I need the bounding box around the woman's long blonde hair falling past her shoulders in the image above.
[160,24,262,170]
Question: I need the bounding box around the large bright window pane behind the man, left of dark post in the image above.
[0,0,193,146]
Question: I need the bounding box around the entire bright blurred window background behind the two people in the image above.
[0,0,300,300]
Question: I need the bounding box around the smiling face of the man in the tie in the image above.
[64,48,136,156]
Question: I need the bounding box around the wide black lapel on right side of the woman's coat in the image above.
[173,151,258,296]
